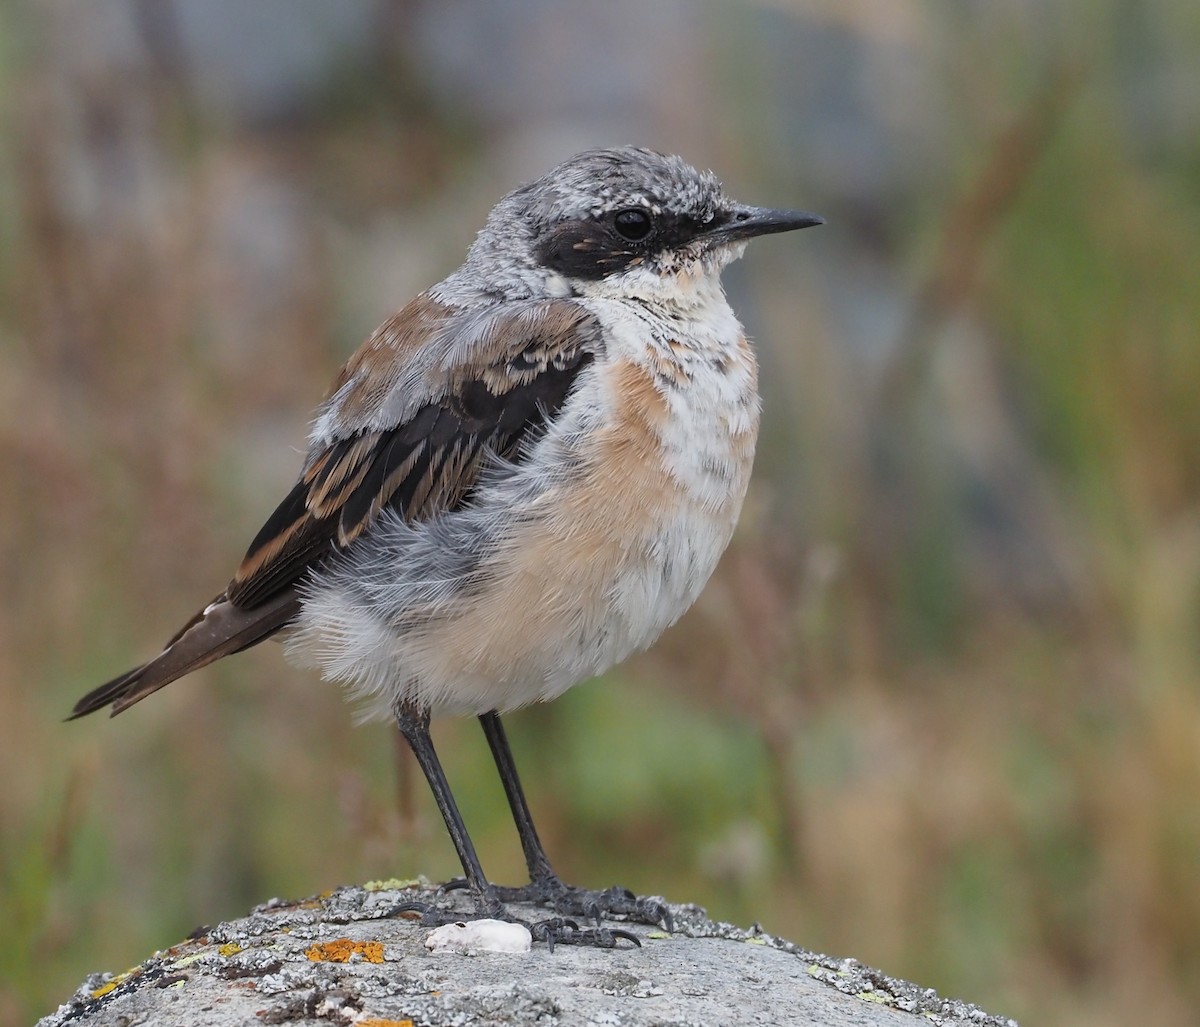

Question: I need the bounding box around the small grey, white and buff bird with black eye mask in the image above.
[68,146,823,948]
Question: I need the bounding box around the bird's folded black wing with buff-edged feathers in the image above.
[228,292,599,608]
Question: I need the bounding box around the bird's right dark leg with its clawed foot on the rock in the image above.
[451,710,673,931]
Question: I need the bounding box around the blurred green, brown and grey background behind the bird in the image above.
[0,0,1200,1027]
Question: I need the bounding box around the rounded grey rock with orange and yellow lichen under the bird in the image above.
[38,881,1015,1027]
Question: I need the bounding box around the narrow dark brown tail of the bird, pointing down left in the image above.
[67,589,300,720]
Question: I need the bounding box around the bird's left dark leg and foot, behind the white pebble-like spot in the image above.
[391,704,641,949]
